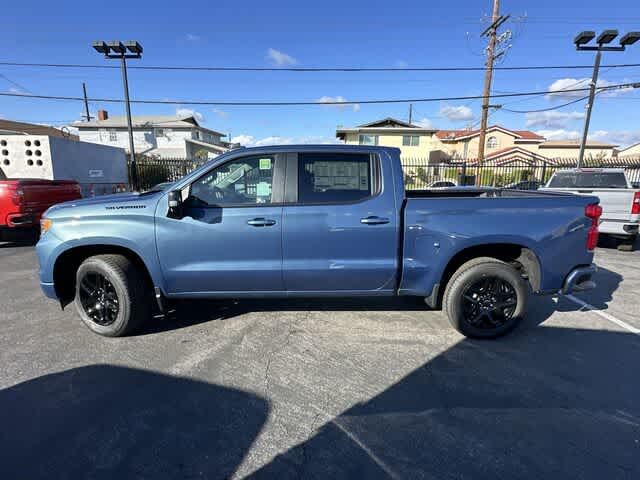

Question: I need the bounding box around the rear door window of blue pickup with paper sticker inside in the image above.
[298,153,374,203]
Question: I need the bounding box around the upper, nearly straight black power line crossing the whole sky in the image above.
[0,62,640,72]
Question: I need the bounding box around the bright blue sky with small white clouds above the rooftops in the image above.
[0,0,640,145]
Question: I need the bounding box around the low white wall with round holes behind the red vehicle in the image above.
[0,135,128,189]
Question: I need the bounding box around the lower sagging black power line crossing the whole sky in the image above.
[0,82,640,107]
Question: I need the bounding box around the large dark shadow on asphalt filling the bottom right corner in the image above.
[252,327,640,479]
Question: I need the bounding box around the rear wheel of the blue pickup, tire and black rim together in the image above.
[442,257,529,338]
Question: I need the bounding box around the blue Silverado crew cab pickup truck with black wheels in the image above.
[37,145,601,338]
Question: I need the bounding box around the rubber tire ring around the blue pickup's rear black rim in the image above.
[446,262,529,338]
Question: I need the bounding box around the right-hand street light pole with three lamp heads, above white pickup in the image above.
[573,30,640,168]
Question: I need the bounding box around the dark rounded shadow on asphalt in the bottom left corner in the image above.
[0,365,269,479]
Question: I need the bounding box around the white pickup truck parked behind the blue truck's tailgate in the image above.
[541,168,640,251]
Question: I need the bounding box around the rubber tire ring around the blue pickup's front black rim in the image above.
[74,259,131,337]
